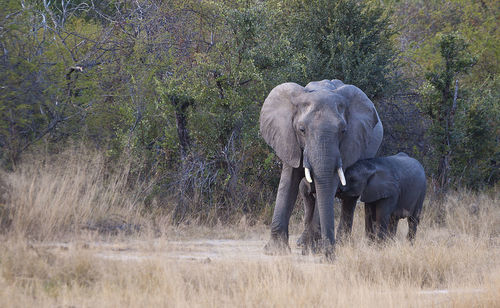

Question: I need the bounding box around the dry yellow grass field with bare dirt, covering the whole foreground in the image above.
[0,155,500,307]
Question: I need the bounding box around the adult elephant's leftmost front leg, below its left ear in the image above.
[264,164,304,254]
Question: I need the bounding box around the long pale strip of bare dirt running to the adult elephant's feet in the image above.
[34,235,321,263]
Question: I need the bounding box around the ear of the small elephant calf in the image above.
[361,167,399,203]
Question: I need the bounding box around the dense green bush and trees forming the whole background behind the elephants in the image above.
[0,0,500,221]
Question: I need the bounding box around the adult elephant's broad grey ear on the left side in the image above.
[260,82,305,168]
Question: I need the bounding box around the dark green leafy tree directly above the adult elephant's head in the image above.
[262,0,397,98]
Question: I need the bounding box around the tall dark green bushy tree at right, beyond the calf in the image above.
[421,34,499,190]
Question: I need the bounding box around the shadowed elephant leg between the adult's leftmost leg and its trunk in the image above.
[297,179,321,254]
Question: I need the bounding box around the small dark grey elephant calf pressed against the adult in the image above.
[340,153,426,242]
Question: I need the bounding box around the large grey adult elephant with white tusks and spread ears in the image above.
[260,80,383,256]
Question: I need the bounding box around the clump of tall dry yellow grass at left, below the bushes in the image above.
[0,148,149,240]
